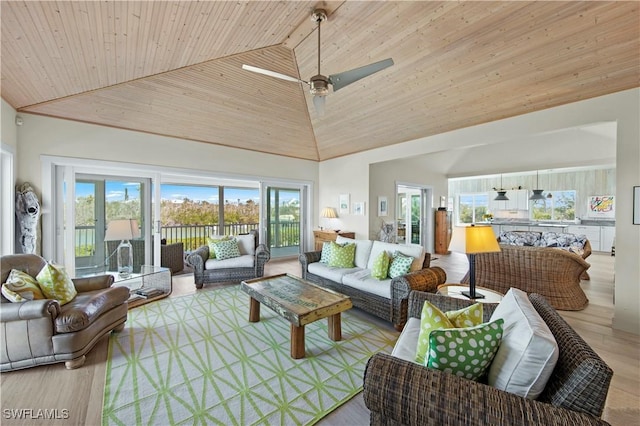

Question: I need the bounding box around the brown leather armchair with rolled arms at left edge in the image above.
[0,254,129,371]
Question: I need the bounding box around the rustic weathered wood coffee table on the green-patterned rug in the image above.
[240,274,353,359]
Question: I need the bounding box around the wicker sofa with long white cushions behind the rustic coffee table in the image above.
[300,236,446,329]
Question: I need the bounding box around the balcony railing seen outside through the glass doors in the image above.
[75,222,300,257]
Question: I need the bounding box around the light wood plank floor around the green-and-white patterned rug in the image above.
[0,253,640,425]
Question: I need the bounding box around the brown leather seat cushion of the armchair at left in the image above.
[55,287,129,333]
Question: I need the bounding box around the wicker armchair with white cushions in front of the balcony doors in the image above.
[187,229,271,289]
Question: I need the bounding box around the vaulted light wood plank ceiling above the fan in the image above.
[1,1,640,161]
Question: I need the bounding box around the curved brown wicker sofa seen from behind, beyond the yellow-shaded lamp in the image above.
[462,244,591,311]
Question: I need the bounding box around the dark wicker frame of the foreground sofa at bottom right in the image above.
[363,292,613,426]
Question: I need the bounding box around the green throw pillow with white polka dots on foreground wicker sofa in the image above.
[427,318,504,380]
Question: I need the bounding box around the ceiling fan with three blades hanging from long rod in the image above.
[242,9,393,115]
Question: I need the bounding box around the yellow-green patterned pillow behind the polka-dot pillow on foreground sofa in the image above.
[416,301,482,365]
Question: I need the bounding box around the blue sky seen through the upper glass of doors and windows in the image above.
[76,181,299,204]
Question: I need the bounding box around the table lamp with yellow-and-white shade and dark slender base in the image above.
[449,224,500,299]
